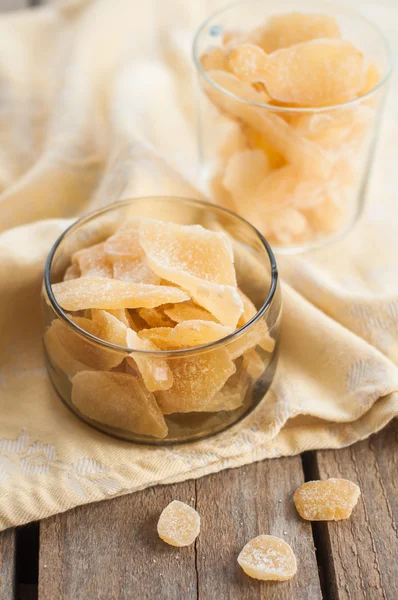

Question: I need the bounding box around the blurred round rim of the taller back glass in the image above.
[192,0,394,114]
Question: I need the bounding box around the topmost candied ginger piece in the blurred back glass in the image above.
[257,12,341,52]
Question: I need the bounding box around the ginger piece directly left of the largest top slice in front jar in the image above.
[105,227,160,285]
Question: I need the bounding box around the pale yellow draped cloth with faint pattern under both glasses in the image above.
[0,0,398,528]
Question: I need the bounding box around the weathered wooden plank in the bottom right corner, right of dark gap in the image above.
[314,419,398,600]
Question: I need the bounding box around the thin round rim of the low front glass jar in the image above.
[44,196,279,358]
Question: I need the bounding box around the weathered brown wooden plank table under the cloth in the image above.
[0,0,398,600]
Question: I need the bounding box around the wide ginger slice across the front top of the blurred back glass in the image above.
[229,40,365,106]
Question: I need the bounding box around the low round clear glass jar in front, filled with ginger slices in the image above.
[42,197,281,444]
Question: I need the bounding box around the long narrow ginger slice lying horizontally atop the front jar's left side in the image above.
[52,277,189,311]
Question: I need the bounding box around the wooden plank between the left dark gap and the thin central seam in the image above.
[39,481,197,600]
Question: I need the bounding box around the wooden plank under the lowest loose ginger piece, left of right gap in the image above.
[196,457,322,600]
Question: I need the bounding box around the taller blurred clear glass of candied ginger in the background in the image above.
[193,0,391,253]
